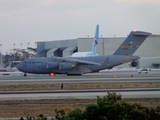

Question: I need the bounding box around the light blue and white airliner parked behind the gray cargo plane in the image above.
[71,25,99,57]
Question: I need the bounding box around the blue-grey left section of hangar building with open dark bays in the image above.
[37,39,78,57]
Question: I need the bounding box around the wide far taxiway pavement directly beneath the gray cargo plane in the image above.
[0,71,160,85]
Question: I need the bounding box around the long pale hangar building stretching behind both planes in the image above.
[37,35,160,68]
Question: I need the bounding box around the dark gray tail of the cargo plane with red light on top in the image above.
[113,31,151,55]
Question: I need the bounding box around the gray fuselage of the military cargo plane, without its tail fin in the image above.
[17,55,139,74]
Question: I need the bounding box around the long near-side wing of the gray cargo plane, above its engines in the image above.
[54,57,101,65]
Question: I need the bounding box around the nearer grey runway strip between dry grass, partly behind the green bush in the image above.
[0,88,160,100]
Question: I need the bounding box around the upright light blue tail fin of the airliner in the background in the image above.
[92,25,99,54]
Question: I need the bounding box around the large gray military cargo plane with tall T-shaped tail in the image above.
[17,31,151,76]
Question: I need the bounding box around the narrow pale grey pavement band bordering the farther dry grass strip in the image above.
[0,77,160,85]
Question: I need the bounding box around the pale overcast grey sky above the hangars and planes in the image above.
[0,0,160,54]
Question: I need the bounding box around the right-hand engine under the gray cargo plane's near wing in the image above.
[59,62,76,70]
